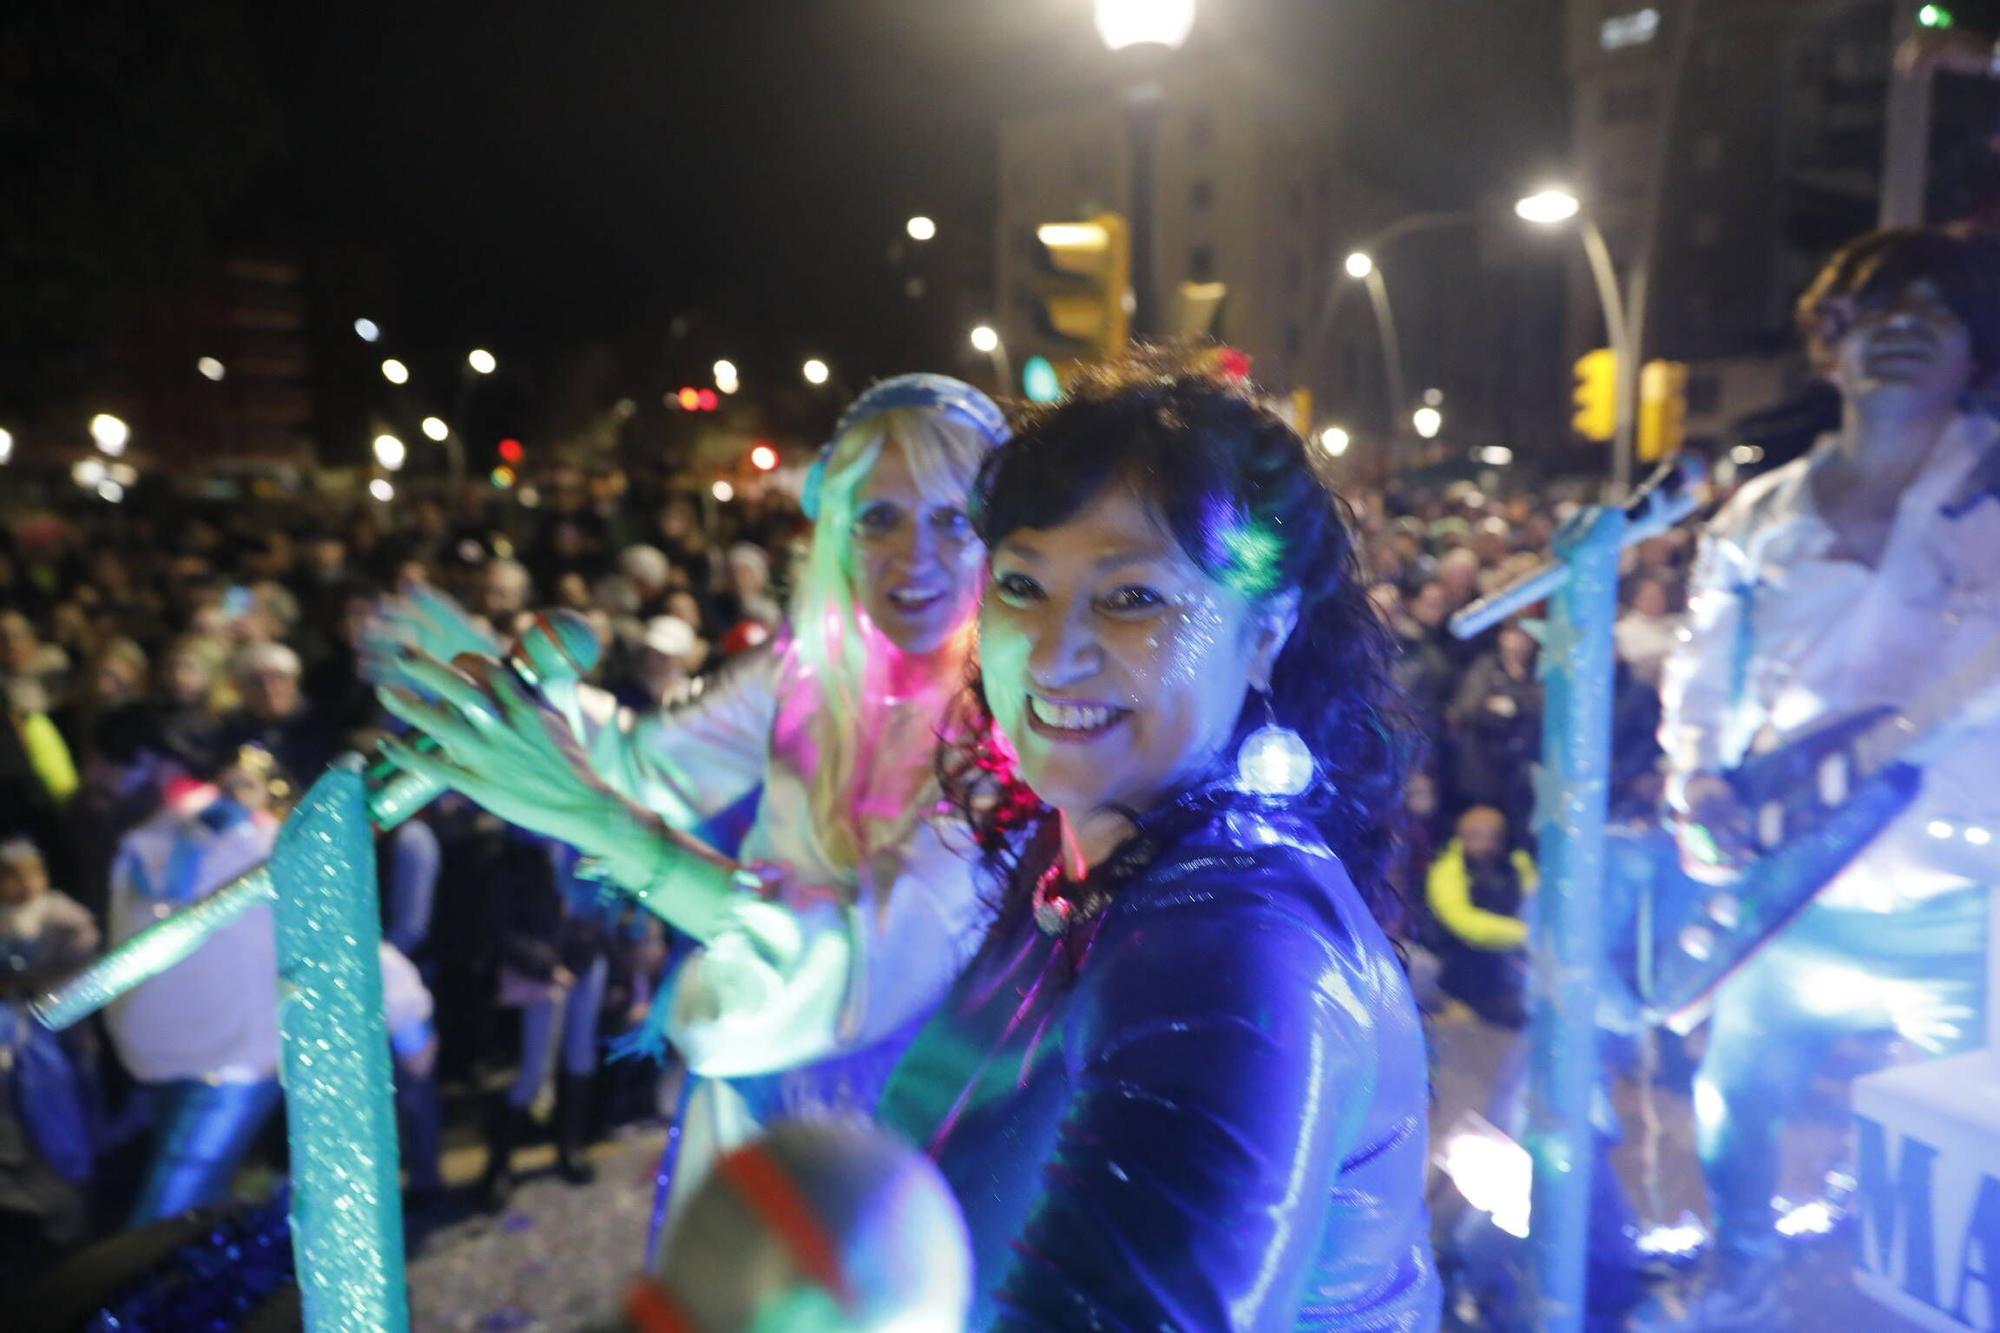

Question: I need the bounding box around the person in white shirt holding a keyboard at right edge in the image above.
[1660,230,2000,1329]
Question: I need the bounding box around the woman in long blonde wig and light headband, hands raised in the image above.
[384,374,1006,1232]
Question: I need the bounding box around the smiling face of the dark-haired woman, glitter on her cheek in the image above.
[980,486,1288,819]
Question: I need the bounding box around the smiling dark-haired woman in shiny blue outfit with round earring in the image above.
[880,360,1438,1329]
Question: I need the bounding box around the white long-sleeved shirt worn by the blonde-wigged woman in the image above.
[550,634,990,1077]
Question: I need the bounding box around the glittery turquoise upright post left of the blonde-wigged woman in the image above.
[272,767,410,1333]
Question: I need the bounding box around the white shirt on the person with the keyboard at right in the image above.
[1660,416,2000,911]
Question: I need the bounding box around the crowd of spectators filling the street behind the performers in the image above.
[0,456,1692,1280]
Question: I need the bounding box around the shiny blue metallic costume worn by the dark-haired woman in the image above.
[880,799,1438,1329]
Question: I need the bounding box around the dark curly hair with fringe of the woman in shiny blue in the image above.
[938,350,1418,935]
